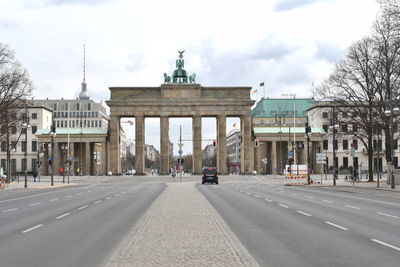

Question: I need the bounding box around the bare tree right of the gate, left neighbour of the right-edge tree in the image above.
[316,38,377,181]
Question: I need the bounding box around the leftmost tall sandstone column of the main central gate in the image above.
[108,115,121,175]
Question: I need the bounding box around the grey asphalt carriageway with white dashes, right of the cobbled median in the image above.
[198,182,400,267]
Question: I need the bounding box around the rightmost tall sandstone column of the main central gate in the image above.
[240,114,254,174]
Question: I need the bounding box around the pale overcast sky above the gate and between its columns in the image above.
[0,0,378,154]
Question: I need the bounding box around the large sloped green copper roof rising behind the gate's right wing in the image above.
[251,98,315,118]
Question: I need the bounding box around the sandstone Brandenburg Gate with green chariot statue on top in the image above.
[106,51,254,175]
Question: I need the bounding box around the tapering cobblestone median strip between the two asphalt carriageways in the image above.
[106,183,258,267]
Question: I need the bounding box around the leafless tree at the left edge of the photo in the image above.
[0,43,32,182]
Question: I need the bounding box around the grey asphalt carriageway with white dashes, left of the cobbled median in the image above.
[0,180,165,267]
